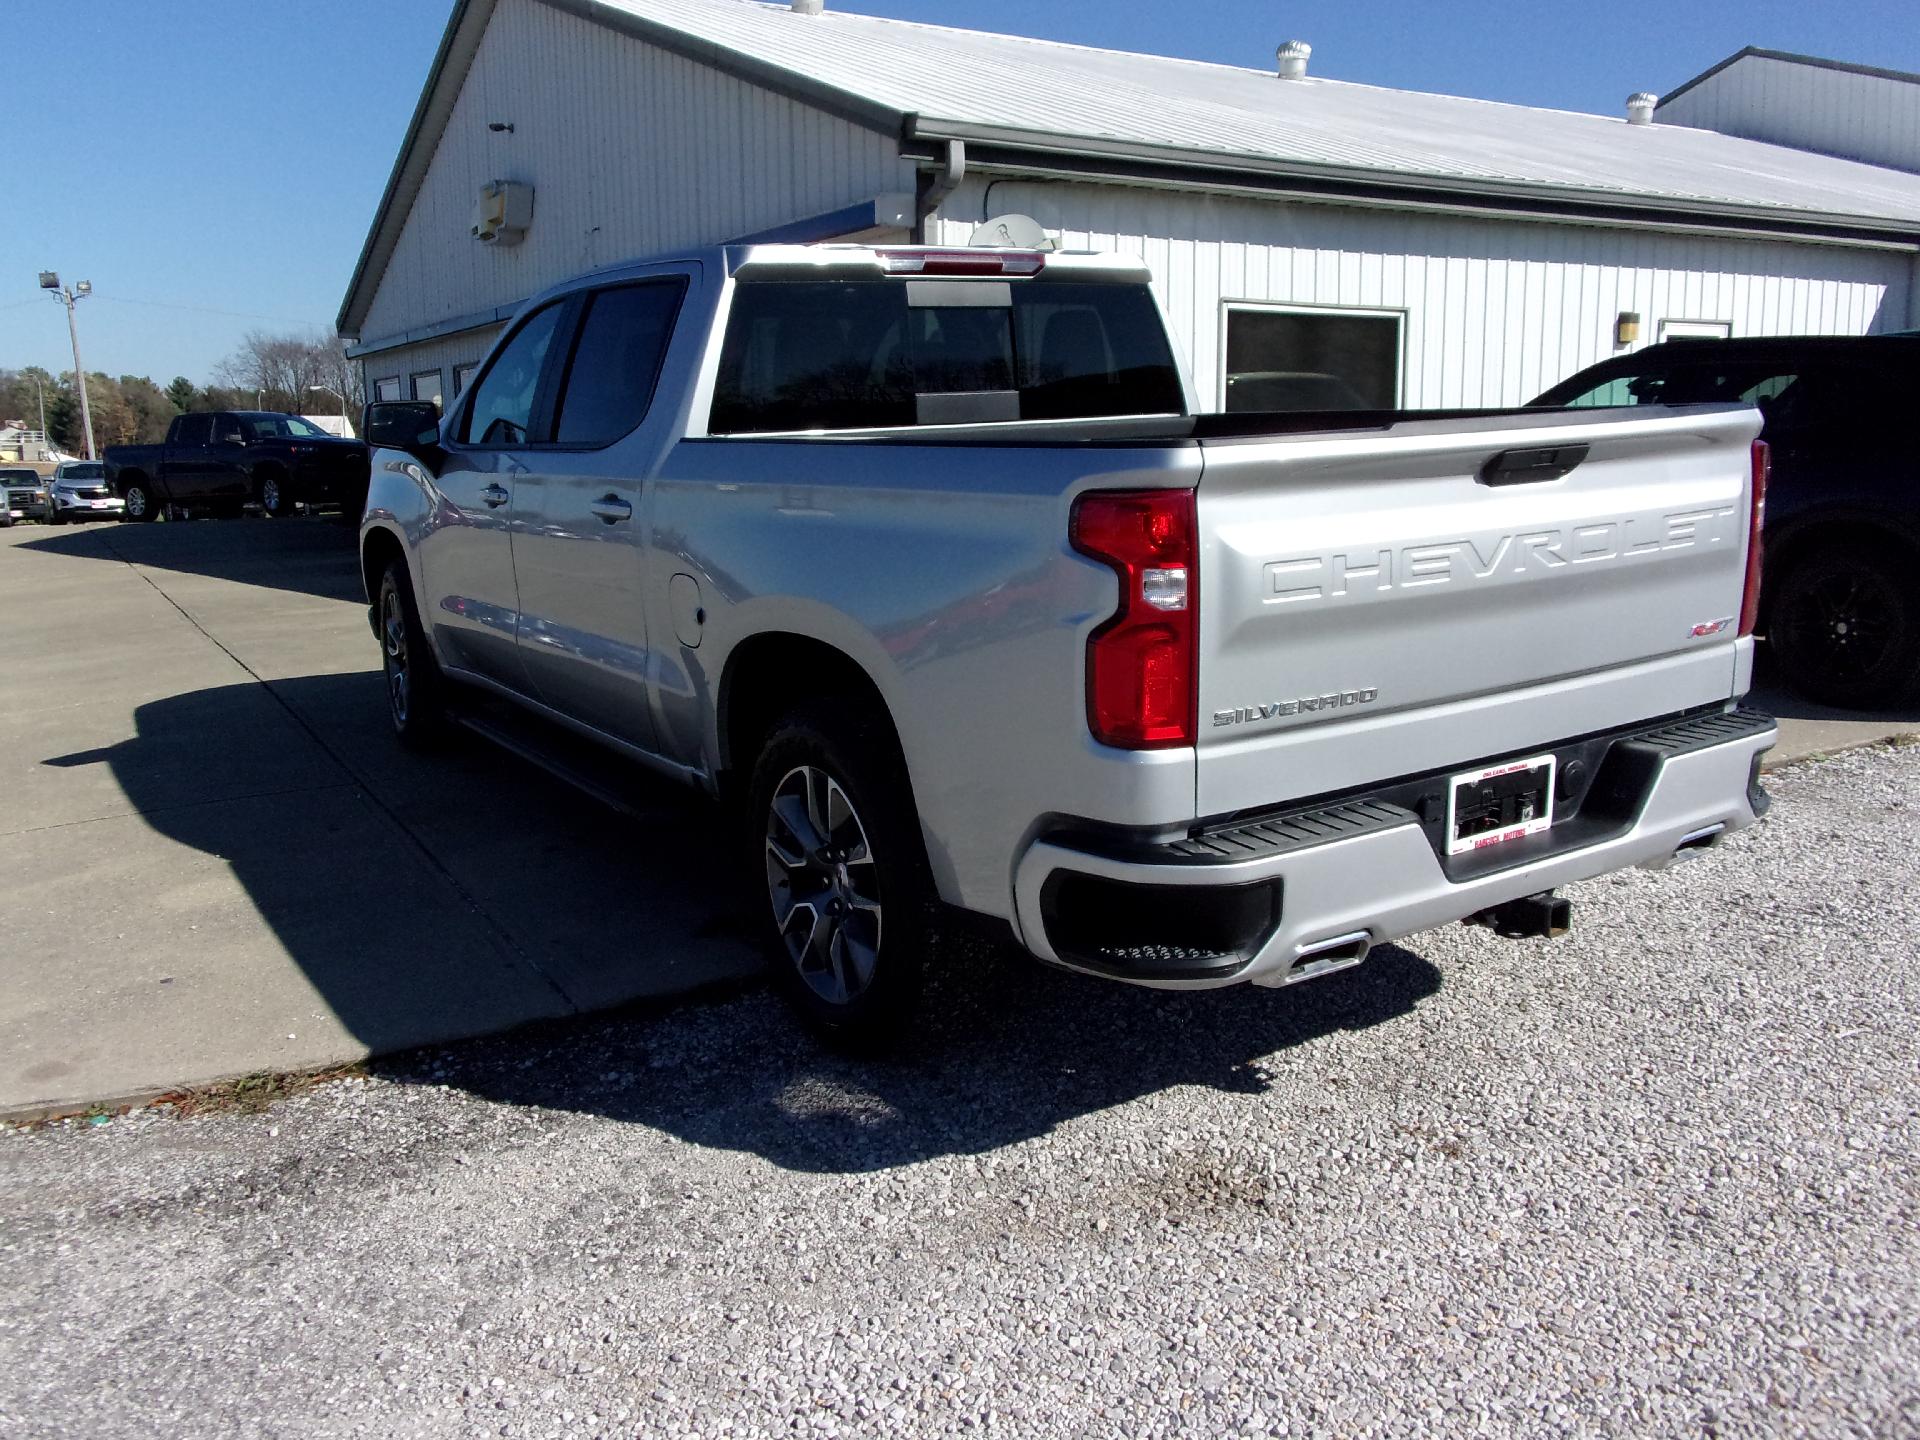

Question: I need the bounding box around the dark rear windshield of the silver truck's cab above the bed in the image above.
[708,280,1185,434]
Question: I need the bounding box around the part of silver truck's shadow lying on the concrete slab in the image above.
[35,670,758,1054]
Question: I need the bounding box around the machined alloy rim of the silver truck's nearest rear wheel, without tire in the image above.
[766,764,879,1004]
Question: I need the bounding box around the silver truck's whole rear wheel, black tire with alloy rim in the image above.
[745,701,935,1048]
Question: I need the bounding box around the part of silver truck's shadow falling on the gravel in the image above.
[374,943,1440,1173]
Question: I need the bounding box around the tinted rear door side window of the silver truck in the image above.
[553,278,685,445]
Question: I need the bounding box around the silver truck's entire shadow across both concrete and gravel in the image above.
[42,672,1440,1173]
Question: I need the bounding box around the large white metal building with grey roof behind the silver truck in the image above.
[340,0,1920,416]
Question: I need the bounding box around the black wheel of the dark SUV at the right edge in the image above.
[1766,551,1920,710]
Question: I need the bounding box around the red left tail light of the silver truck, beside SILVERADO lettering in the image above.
[1069,490,1200,751]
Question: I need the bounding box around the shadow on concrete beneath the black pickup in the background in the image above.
[21,516,367,601]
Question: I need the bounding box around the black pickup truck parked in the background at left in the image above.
[106,411,367,520]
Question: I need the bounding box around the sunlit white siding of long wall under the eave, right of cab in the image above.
[933,179,1914,409]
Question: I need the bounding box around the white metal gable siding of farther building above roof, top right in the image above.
[1655,56,1920,171]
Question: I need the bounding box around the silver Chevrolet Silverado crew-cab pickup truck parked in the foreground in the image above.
[361,246,1774,1033]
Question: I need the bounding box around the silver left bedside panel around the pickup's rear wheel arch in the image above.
[647,440,1200,914]
